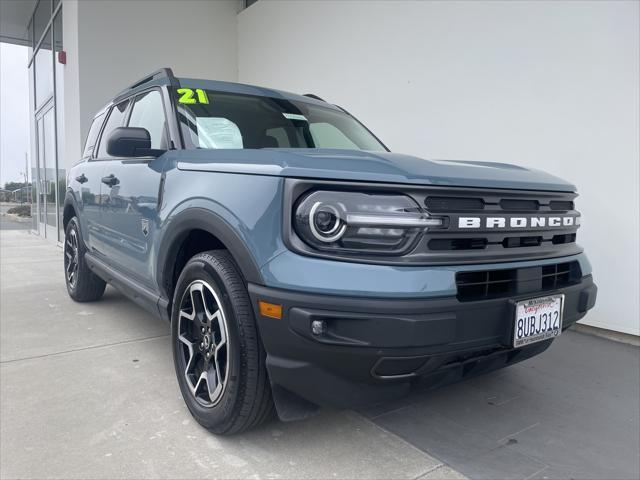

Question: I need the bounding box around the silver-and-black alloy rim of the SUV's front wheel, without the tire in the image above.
[178,280,229,407]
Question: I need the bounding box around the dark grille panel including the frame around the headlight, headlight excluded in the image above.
[283,179,582,265]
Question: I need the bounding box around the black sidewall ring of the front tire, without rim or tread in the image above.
[171,257,242,428]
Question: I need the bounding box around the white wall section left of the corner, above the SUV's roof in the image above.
[63,0,240,162]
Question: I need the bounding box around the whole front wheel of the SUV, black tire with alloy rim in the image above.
[171,250,274,435]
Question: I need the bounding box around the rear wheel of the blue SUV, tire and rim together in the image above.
[64,217,107,302]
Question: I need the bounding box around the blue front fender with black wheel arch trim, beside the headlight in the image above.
[154,170,285,299]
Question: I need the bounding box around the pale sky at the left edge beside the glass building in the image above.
[0,43,31,187]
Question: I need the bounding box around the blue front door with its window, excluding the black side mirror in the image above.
[95,88,170,287]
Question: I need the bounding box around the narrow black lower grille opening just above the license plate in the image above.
[456,261,582,302]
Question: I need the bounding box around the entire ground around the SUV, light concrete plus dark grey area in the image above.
[0,231,640,480]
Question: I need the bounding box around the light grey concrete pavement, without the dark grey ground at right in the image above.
[0,231,463,479]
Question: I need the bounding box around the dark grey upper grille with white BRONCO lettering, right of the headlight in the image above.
[408,187,581,262]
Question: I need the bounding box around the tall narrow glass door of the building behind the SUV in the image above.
[36,103,58,238]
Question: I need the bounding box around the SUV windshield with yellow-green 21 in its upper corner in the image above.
[174,88,386,151]
